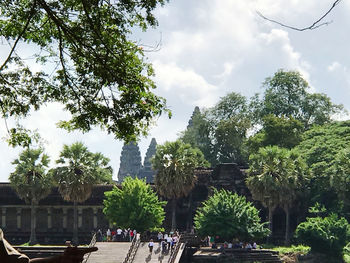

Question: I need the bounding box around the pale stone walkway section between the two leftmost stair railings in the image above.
[87,242,131,263]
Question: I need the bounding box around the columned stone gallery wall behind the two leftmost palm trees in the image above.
[0,183,112,244]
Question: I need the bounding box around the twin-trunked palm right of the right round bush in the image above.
[246,146,307,244]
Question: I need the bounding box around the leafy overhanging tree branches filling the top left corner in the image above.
[0,0,167,146]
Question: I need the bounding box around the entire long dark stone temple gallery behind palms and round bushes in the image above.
[0,164,268,244]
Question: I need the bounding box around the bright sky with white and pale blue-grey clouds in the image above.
[0,0,350,182]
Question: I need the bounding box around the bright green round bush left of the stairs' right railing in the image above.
[103,177,166,232]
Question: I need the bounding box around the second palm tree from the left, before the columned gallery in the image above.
[53,142,112,244]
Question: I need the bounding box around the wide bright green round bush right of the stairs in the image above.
[194,189,269,241]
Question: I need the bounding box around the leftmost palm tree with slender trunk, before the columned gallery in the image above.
[9,148,52,245]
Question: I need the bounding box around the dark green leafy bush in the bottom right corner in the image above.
[295,214,349,257]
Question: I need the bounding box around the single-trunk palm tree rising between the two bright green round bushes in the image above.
[152,140,208,230]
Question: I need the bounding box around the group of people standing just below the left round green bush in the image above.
[96,227,137,242]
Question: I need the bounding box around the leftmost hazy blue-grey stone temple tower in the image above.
[118,142,142,182]
